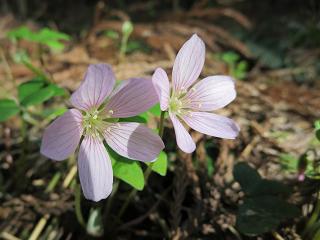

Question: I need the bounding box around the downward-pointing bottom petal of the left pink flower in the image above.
[78,136,113,202]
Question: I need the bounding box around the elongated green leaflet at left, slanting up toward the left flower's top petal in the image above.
[21,85,55,107]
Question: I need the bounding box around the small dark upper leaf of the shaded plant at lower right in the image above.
[233,162,261,194]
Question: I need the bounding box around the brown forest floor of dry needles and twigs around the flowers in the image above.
[0,0,320,239]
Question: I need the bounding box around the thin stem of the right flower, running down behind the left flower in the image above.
[114,111,165,224]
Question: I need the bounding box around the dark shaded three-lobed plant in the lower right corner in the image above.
[233,163,300,236]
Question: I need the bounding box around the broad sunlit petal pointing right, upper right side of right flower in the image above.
[185,76,236,111]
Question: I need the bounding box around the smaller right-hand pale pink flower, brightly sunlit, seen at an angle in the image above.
[152,34,240,153]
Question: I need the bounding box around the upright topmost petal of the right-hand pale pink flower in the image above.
[172,34,205,92]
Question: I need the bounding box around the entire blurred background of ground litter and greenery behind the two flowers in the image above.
[0,0,320,240]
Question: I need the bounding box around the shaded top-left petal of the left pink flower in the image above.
[70,64,115,110]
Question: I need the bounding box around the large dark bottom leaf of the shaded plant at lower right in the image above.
[236,196,300,236]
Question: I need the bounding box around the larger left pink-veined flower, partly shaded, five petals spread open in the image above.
[41,64,164,201]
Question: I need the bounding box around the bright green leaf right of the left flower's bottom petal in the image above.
[108,147,144,190]
